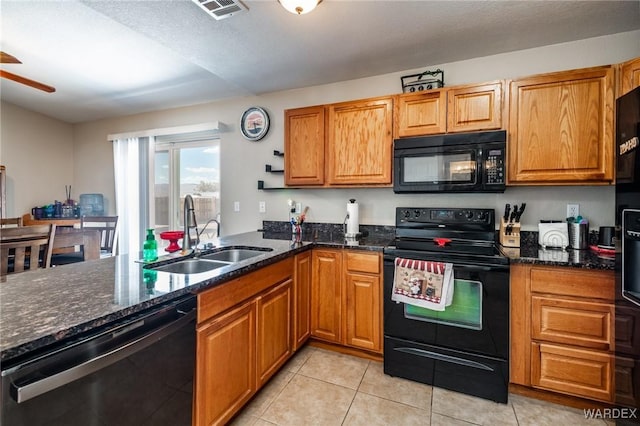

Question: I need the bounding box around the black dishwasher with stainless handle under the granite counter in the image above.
[0,295,196,426]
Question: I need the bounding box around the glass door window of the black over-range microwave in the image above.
[402,151,477,184]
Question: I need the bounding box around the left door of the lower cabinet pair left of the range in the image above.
[311,250,342,343]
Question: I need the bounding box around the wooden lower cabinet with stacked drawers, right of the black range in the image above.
[510,264,615,402]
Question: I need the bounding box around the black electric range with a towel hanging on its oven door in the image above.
[384,207,509,403]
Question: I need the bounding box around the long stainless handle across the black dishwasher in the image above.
[10,309,196,404]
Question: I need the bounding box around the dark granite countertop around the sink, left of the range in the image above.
[0,227,393,362]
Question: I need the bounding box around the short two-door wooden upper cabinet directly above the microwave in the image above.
[394,81,504,138]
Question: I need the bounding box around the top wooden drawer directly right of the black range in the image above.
[531,268,615,301]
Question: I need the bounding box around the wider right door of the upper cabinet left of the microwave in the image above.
[327,97,393,185]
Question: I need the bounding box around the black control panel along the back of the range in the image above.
[396,207,495,227]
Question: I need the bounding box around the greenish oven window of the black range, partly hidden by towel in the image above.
[404,280,482,330]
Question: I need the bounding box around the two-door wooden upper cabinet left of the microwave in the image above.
[284,96,393,186]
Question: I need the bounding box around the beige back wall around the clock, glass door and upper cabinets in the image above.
[0,31,640,234]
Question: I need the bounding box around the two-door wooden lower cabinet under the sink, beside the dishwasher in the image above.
[193,258,294,425]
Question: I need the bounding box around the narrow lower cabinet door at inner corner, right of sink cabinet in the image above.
[293,251,311,351]
